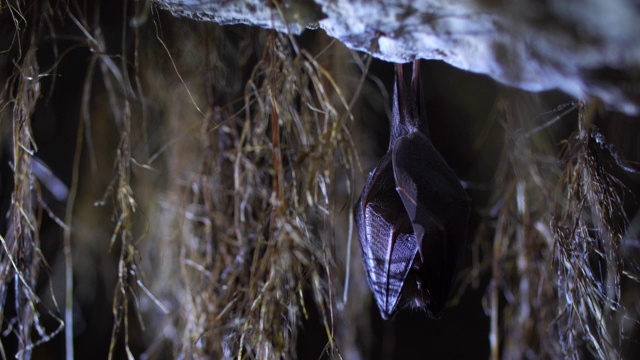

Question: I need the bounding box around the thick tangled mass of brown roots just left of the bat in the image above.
[139,17,352,359]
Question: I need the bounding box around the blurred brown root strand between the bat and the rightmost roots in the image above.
[476,93,558,359]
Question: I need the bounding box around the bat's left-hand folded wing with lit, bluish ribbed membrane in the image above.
[355,154,418,319]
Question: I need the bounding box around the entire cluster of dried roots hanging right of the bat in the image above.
[474,94,638,359]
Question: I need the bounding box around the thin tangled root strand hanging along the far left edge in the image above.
[0,2,64,359]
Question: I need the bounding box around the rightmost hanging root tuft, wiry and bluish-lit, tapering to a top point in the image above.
[551,104,628,359]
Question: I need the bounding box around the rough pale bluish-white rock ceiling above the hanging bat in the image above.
[155,0,640,114]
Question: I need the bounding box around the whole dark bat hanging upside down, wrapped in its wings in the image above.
[355,60,470,319]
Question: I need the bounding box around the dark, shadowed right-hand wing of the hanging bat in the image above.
[392,132,470,314]
